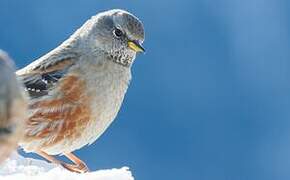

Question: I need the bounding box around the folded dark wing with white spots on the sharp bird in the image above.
[16,50,77,98]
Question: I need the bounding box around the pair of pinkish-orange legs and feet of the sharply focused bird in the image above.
[36,151,89,173]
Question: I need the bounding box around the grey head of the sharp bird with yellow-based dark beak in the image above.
[78,9,145,66]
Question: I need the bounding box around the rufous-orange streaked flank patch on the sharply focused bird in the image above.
[26,75,90,147]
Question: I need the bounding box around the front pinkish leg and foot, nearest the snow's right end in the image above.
[63,153,90,173]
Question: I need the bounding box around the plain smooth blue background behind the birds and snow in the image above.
[0,0,290,180]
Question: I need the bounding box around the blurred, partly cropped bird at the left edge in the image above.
[0,50,27,163]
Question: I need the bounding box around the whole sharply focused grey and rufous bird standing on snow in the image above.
[16,9,145,173]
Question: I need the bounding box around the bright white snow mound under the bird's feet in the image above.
[0,153,134,180]
